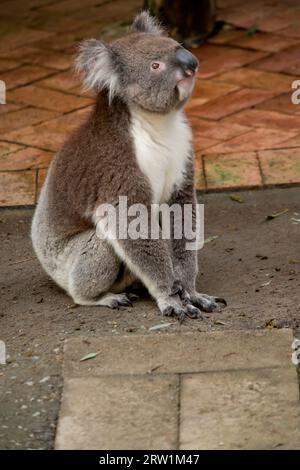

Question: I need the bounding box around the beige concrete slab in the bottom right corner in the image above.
[180,367,300,449]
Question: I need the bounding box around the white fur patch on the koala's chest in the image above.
[131,111,191,204]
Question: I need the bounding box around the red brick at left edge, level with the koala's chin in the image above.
[0,107,59,137]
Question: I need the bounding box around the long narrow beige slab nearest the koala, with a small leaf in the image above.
[64,329,293,377]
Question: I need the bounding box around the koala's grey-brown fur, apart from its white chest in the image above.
[32,13,225,318]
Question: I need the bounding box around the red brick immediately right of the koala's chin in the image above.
[197,88,273,119]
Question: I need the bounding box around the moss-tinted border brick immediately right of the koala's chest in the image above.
[204,152,262,189]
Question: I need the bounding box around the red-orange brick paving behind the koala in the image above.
[0,0,300,206]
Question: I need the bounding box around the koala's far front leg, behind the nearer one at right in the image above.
[169,159,198,295]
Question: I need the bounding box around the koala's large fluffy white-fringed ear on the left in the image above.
[75,39,118,102]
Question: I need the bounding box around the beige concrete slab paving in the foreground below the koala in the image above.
[56,329,300,450]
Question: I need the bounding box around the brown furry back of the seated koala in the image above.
[31,95,149,274]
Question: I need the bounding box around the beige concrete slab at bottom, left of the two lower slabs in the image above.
[55,375,179,450]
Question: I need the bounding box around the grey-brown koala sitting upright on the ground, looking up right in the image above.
[31,11,226,319]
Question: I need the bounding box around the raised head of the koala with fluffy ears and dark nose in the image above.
[77,12,198,113]
